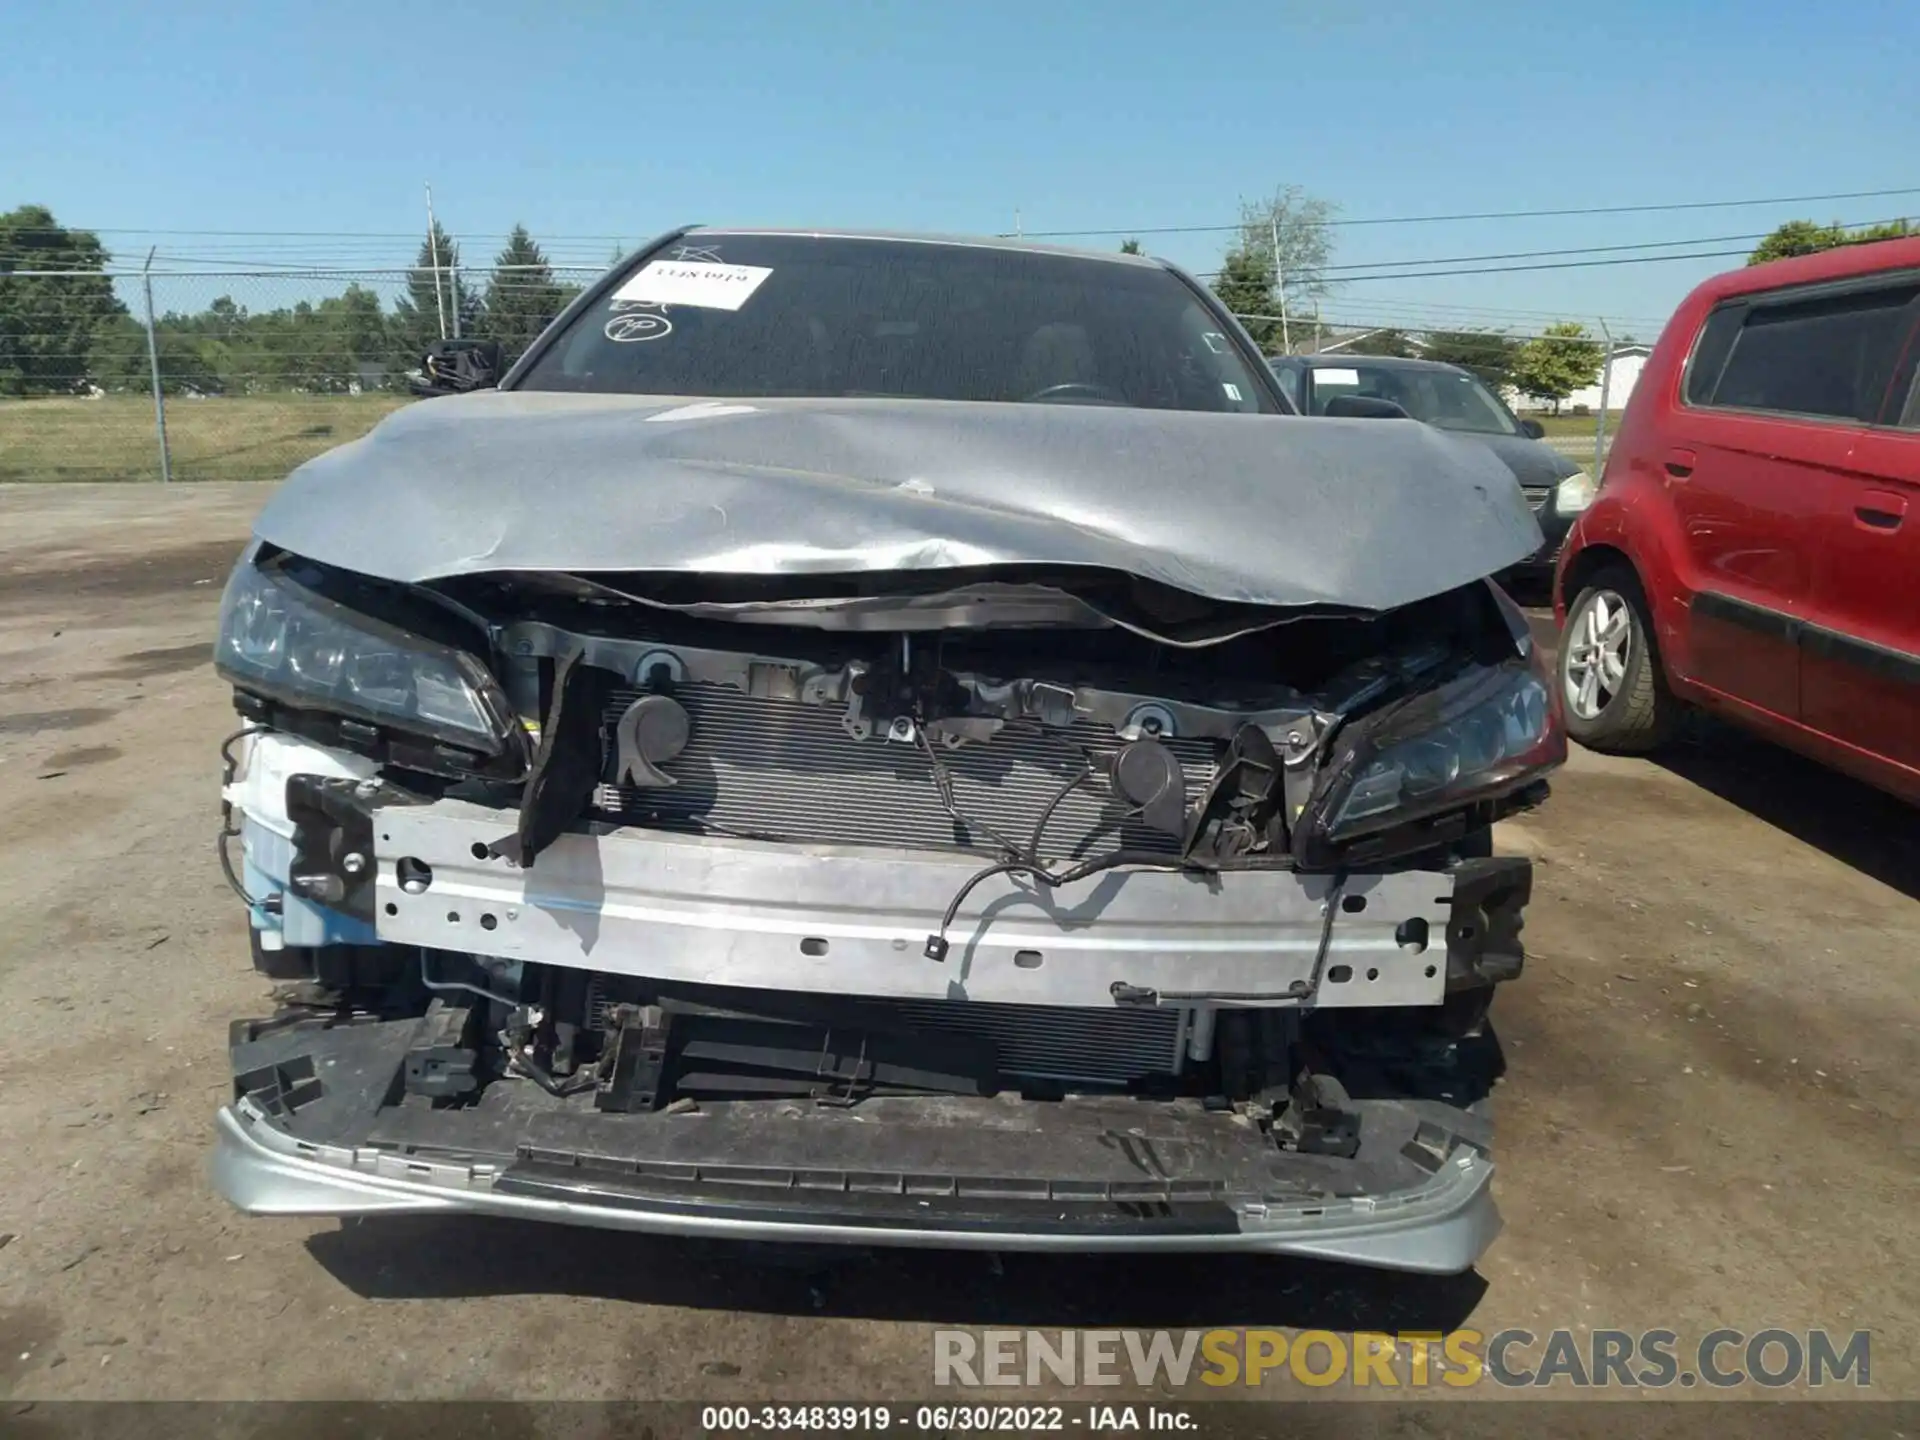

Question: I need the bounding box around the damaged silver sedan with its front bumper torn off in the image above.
[215,230,1565,1271]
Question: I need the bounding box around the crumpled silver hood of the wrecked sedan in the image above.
[255,392,1542,611]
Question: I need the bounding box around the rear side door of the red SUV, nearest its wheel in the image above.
[1651,282,1912,722]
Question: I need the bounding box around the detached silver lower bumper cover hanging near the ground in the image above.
[213,1098,1500,1275]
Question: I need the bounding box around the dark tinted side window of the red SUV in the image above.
[1686,280,1920,420]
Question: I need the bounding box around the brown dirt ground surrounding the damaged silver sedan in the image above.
[0,486,1920,1402]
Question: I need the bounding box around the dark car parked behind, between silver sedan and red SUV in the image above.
[1269,351,1594,588]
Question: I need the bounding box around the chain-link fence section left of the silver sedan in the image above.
[0,265,603,482]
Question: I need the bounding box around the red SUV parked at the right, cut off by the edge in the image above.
[1553,238,1920,804]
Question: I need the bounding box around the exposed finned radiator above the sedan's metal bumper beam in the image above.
[593,684,1217,856]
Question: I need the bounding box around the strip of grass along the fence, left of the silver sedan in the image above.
[0,396,407,482]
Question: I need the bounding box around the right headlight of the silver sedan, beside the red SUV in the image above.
[1321,662,1567,843]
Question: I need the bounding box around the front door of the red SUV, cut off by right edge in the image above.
[1801,298,1920,785]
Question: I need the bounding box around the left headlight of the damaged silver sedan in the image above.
[213,557,513,756]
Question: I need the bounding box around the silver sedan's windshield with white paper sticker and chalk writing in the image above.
[520,232,1281,415]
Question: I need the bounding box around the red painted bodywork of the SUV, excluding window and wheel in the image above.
[1553,238,1920,804]
